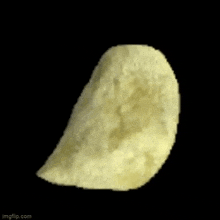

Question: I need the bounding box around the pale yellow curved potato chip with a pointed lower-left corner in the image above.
[38,45,179,190]
